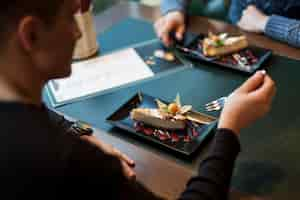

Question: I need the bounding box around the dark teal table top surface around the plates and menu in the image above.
[44,19,300,200]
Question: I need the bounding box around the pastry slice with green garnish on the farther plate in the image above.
[202,33,248,57]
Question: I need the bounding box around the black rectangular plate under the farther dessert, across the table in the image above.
[175,34,272,74]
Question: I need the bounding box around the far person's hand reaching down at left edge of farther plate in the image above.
[154,11,186,46]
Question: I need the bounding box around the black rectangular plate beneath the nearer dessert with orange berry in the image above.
[106,93,217,156]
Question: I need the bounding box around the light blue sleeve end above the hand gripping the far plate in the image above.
[160,0,190,15]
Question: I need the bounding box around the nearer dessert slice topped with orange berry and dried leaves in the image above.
[130,94,216,143]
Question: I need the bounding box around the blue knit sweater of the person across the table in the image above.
[161,0,300,47]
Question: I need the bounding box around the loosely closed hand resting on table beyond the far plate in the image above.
[237,5,269,33]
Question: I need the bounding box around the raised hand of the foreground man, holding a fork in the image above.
[218,71,276,134]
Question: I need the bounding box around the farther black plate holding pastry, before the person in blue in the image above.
[175,34,272,74]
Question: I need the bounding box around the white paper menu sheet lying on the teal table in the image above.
[47,48,154,106]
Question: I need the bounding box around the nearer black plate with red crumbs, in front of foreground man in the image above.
[106,93,217,156]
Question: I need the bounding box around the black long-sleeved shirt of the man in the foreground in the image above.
[0,102,240,200]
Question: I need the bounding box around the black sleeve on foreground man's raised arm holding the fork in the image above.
[179,129,240,200]
